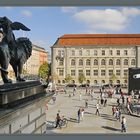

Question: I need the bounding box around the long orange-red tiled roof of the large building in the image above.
[54,34,140,46]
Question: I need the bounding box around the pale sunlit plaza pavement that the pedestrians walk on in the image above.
[46,88,140,134]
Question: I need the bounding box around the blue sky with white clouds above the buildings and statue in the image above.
[0,6,140,52]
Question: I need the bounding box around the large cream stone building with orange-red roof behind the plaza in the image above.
[52,34,140,84]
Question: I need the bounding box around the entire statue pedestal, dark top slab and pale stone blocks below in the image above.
[0,81,54,134]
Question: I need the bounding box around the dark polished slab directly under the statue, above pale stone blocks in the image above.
[0,81,46,109]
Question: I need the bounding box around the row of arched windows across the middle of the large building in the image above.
[59,59,136,66]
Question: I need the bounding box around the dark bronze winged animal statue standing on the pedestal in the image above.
[0,17,32,83]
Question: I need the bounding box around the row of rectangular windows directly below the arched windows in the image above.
[59,69,128,76]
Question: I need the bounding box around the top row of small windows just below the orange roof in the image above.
[58,49,135,56]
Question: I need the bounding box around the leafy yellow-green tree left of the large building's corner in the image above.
[38,62,51,79]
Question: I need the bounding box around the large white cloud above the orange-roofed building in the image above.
[73,8,140,32]
